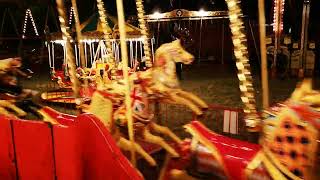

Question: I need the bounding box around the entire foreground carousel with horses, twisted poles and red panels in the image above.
[0,0,320,180]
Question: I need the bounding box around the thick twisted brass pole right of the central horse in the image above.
[226,0,260,128]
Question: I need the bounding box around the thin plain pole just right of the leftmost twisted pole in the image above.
[71,0,86,68]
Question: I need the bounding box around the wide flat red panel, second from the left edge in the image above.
[13,120,54,180]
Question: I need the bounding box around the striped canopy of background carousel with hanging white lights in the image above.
[47,9,155,69]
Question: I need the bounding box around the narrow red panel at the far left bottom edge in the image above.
[0,116,16,180]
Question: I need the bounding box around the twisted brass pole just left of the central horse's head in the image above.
[136,0,152,67]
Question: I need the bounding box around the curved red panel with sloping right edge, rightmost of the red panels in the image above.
[76,115,142,180]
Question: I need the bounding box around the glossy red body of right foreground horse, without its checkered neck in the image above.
[162,121,261,179]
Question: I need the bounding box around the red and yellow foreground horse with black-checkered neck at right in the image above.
[171,80,320,180]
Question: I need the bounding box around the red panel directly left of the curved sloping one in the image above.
[53,125,83,180]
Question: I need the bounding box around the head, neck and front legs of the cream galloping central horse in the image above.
[100,40,208,115]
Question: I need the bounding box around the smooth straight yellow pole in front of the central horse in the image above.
[117,0,136,166]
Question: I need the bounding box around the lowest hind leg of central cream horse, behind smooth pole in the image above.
[117,137,157,166]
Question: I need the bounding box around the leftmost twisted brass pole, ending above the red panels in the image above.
[56,0,79,98]
